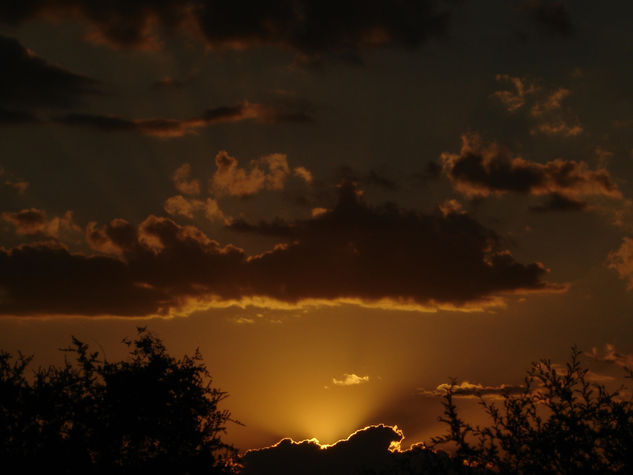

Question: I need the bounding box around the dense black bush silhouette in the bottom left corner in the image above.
[0,328,235,475]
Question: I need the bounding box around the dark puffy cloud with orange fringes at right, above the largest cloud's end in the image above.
[441,135,622,200]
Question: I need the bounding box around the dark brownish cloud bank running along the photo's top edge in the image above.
[0,0,451,58]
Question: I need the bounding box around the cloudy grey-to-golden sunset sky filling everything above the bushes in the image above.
[0,0,633,460]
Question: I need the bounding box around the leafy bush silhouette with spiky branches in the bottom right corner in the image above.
[432,347,633,474]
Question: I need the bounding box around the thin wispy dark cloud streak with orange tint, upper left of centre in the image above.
[54,102,312,138]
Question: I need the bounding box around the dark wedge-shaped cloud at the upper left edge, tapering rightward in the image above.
[0,34,98,110]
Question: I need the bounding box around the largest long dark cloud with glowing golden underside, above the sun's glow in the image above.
[0,185,562,315]
